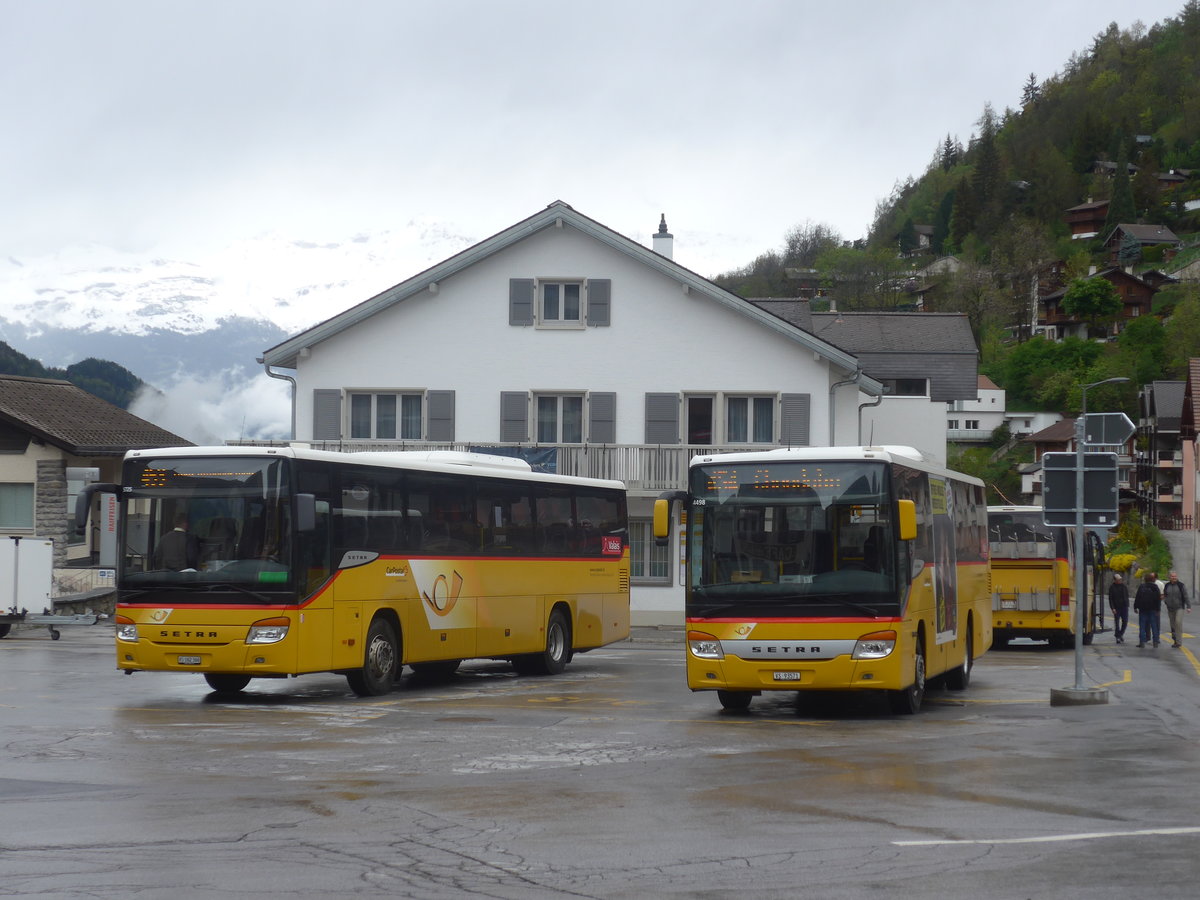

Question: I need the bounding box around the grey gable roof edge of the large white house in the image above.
[259,200,883,395]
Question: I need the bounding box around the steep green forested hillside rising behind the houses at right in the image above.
[715,0,1200,415]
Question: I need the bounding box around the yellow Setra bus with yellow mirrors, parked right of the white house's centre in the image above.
[655,446,991,713]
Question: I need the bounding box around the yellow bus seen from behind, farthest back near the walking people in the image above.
[988,506,1099,648]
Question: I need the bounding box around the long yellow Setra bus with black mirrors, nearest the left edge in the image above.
[76,448,629,696]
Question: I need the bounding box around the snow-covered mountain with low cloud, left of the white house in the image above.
[0,221,478,443]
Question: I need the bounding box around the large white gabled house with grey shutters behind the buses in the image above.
[259,202,974,624]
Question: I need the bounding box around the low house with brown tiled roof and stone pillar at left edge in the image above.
[0,376,191,589]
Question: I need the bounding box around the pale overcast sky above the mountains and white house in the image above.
[0,0,1183,281]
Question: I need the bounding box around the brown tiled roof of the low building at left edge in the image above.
[0,376,191,456]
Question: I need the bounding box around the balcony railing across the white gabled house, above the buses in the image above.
[228,440,772,494]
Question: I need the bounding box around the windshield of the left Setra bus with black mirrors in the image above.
[120,456,292,593]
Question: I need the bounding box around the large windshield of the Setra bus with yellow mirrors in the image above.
[686,461,908,616]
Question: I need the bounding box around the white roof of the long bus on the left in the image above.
[125,445,625,491]
